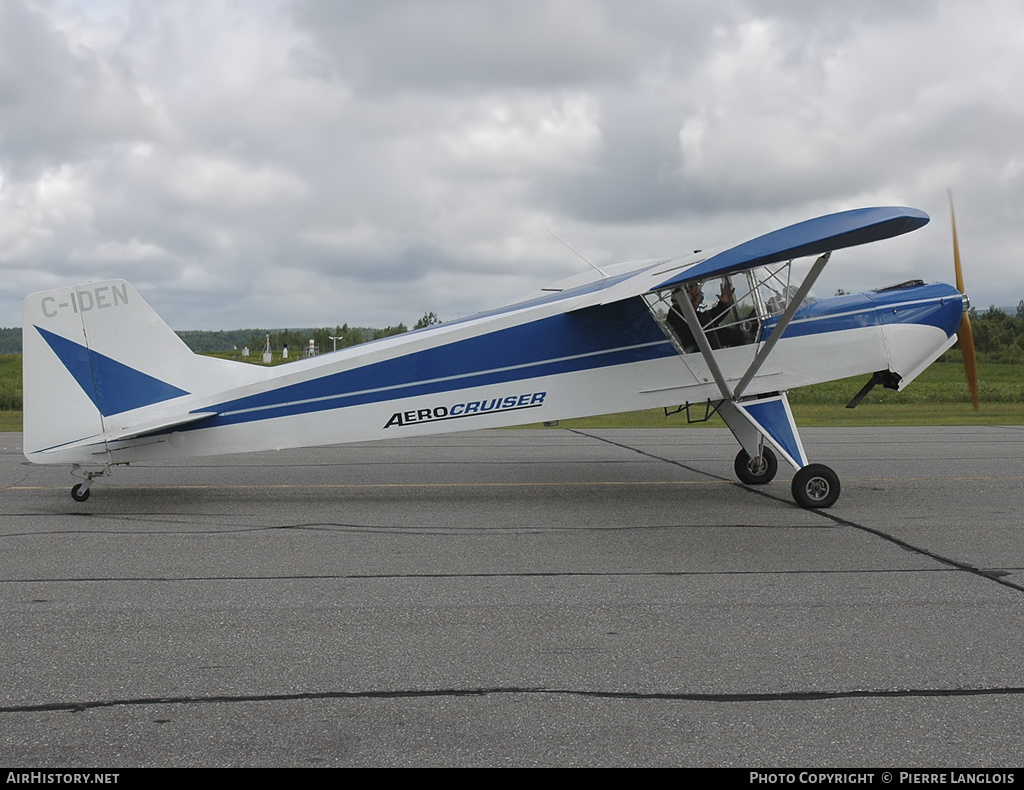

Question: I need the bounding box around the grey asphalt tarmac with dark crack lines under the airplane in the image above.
[0,426,1024,767]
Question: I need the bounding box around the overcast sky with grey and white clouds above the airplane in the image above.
[0,0,1024,329]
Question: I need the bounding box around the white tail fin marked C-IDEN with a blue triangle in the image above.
[22,280,263,462]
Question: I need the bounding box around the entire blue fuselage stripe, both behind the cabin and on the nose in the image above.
[180,285,962,429]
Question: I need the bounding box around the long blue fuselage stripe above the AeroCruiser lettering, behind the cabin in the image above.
[197,297,676,428]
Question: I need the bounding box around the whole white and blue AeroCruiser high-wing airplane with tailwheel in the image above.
[23,207,976,507]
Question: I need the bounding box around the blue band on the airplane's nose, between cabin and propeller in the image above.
[761,283,964,340]
